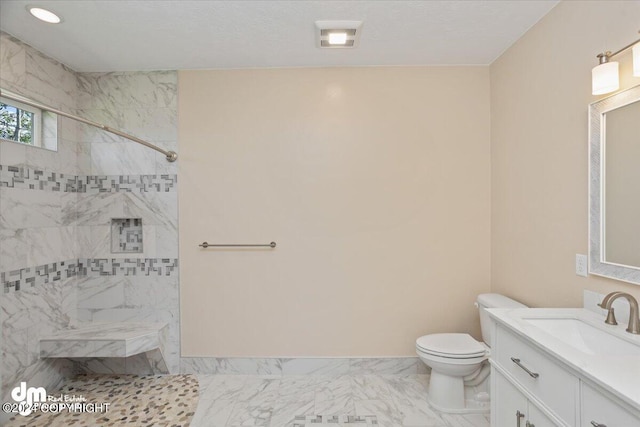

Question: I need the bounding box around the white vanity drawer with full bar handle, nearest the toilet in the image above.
[493,326,579,426]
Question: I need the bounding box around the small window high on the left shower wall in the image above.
[0,98,42,147]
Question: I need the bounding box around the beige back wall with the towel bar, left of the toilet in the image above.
[179,67,490,357]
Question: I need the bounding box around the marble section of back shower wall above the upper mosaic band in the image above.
[79,71,178,175]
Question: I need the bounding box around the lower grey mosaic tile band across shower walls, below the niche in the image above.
[0,258,178,293]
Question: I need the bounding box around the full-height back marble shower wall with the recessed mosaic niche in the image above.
[74,71,180,372]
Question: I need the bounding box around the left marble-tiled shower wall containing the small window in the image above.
[0,33,82,402]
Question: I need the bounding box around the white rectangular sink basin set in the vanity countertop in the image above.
[523,317,640,356]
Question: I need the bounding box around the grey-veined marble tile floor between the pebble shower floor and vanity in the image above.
[191,375,489,427]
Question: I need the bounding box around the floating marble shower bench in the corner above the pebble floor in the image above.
[40,322,169,371]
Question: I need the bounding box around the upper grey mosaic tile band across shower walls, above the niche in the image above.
[0,165,178,193]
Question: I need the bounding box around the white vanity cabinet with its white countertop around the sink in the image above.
[490,309,640,427]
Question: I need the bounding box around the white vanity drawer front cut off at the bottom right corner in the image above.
[580,383,640,427]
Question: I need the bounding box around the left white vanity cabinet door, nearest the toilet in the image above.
[491,370,528,427]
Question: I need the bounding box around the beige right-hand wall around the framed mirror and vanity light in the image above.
[491,1,640,307]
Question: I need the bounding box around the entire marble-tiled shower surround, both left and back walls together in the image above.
[0,33,179,404]
